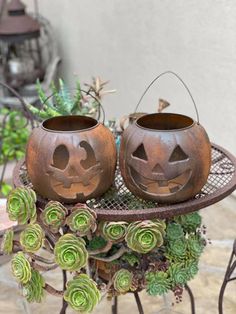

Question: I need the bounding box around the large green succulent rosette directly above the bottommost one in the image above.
[54,233,88,271]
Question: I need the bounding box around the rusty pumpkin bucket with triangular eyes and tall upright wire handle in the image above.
[119,72,211,203]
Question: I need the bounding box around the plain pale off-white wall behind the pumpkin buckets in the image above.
[24,0,236,154]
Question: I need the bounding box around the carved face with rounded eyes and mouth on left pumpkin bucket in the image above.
[47,141,102,199]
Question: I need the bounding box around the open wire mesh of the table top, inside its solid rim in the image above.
[15,146,236,212]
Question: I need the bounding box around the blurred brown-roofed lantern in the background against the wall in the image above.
[0,0,44,89]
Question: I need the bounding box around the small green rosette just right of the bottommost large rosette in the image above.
[113,269,133,293]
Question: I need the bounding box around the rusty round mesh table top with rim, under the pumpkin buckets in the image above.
[14,144,236,221]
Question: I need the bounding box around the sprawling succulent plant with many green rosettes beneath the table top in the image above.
[1,187,206,313]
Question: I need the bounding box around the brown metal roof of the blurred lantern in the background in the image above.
[0,0,40,42]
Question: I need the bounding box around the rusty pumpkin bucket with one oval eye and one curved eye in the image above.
[26,116,116,203]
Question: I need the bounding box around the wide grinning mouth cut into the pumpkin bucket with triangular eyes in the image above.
[130,166,192,196]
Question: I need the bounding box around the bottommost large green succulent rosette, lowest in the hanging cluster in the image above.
[64,274,101,313]
